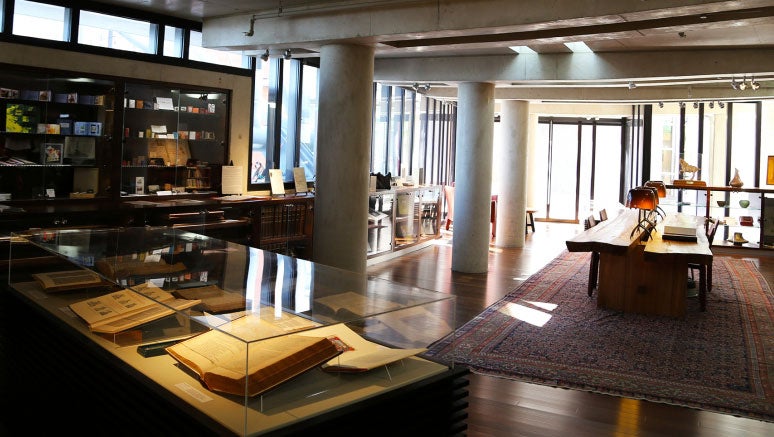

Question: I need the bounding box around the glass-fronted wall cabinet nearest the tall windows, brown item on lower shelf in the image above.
[121,84,229,196]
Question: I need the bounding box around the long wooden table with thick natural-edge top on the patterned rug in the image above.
[566,210,712,317]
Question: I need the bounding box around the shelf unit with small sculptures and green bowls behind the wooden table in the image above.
[662,185,774,249]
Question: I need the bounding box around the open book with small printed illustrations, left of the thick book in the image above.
[70,284,200,334]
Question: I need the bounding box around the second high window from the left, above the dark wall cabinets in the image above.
[78,11,156,53]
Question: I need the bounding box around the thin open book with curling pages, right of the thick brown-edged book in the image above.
[299,323,427,373]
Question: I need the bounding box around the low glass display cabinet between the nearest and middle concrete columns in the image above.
[368,186,441,258]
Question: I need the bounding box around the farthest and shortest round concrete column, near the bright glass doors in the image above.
[493,100,529,247]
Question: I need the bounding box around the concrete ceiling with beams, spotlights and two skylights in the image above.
[88,0,774,101]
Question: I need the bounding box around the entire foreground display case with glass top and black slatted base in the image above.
[3,227,467,435]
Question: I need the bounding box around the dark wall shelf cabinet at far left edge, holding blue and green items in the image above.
[0,66,115,202]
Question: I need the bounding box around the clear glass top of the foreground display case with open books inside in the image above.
[9,227,466,435]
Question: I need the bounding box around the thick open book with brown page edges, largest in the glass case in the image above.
[167,319,341,396]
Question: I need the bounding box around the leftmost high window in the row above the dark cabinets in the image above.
[13,0,65,41]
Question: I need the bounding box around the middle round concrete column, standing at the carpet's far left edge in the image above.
[452,82,494,273]
